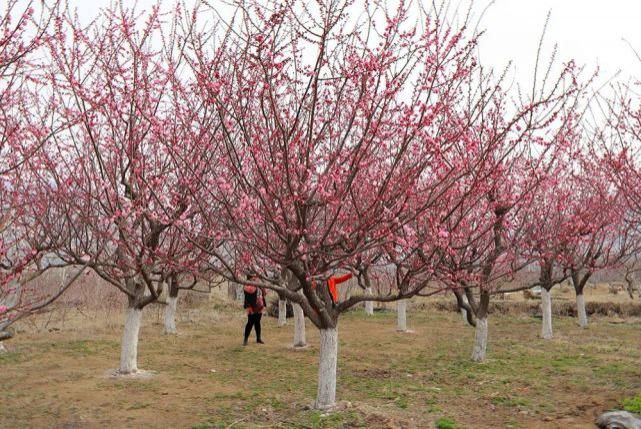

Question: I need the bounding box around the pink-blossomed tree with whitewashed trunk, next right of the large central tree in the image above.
[390,51,584,361]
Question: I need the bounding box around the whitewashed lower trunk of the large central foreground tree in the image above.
[315,328,338,410]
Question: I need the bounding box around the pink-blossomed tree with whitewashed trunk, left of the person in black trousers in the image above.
[43,6,209,374]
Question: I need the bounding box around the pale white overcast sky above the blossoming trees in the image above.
[63,0,641,85]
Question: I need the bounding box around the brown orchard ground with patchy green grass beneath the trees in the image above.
[0,282,641,428]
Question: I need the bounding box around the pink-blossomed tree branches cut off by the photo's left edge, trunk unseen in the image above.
[0,0,66,349]
